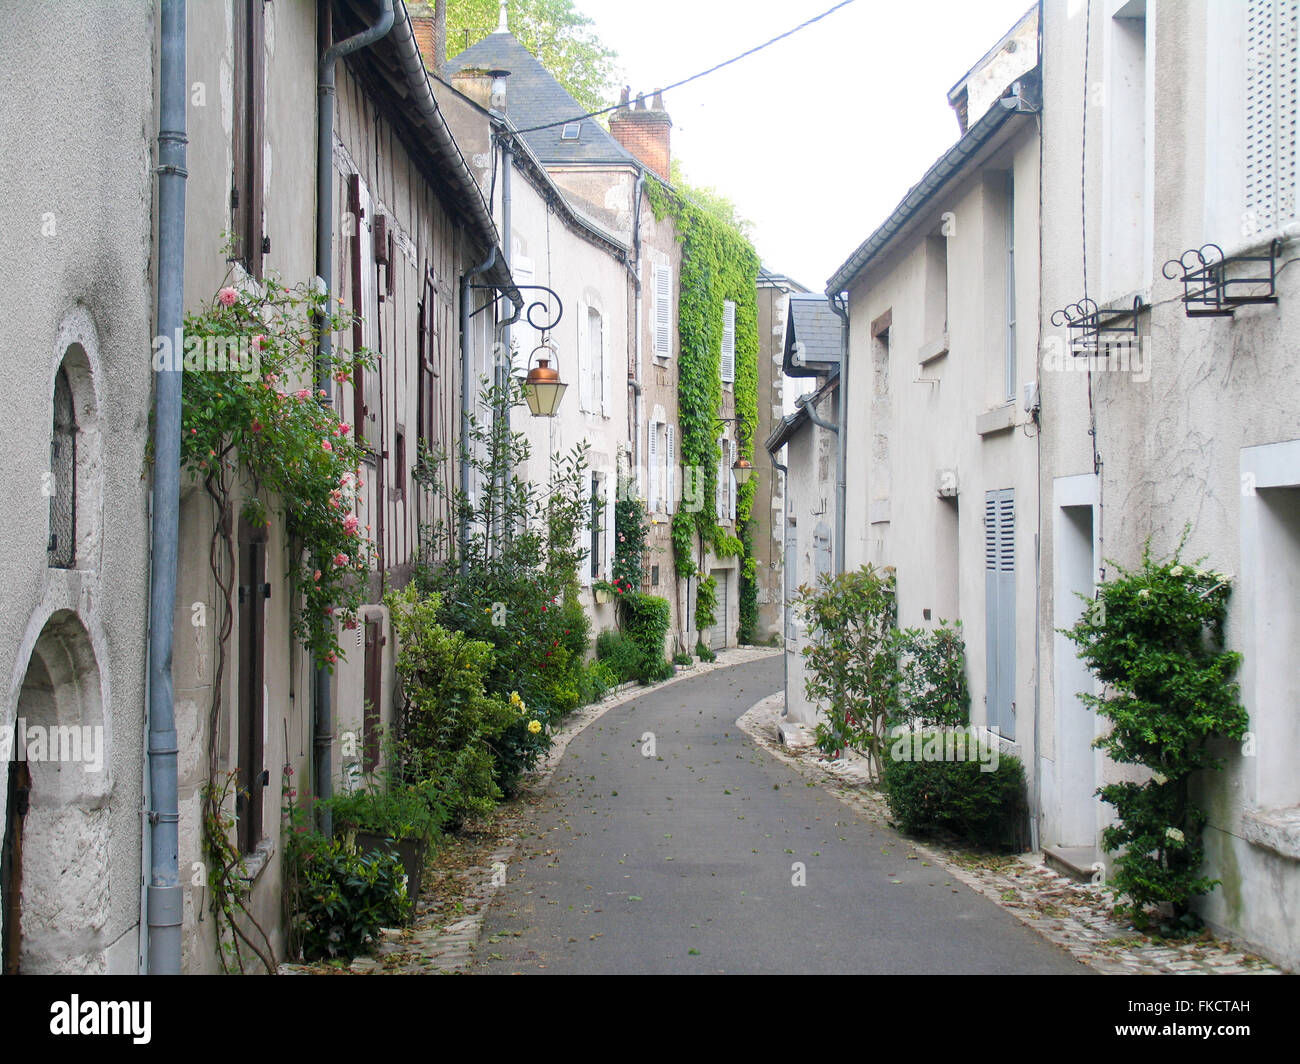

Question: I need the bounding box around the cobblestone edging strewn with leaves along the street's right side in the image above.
[736,692,1283,976]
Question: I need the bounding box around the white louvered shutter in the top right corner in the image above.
[1245,0,1300,232]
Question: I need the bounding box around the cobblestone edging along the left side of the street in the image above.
[280,646,781,976]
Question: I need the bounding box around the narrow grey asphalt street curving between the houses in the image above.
[473,656,1088,974]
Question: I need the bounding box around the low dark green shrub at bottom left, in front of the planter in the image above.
[287,832,411,960]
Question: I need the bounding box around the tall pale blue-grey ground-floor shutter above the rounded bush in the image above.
[984,488,1015,739]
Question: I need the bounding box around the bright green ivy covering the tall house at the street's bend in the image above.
[646,180,759,643]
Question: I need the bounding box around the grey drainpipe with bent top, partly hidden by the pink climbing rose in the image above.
[312,0,393,835]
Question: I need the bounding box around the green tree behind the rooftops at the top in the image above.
[441,0,618,111]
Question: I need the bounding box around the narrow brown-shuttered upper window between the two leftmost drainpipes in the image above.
[230,0,267,281]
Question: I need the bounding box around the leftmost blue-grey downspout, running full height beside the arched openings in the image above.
[146,0,189,976]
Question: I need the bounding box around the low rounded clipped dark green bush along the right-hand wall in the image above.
[884,728,1026,849]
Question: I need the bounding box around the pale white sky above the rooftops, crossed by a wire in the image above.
[575,0,1031,291]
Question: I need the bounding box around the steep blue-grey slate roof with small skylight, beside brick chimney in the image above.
[446,33,642,169]
